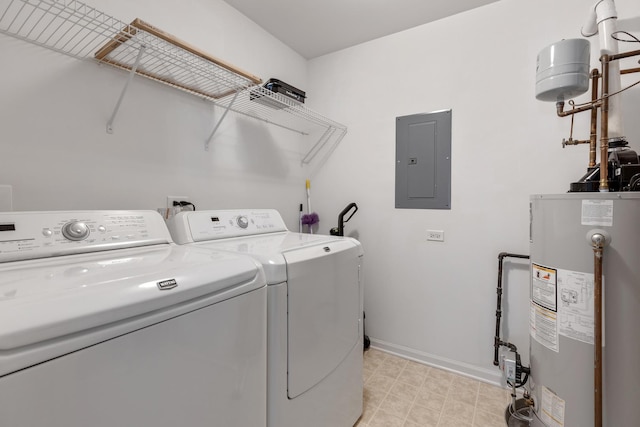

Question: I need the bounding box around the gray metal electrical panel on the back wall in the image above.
[396,110,451,209]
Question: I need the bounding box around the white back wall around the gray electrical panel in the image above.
[309,0,640,382]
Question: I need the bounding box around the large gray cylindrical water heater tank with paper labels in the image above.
[530,192,640,427]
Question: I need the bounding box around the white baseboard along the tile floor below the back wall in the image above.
[371,338,504,387]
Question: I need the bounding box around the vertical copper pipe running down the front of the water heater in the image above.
[591,233,606,427]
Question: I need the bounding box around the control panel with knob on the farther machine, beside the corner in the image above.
[167,209,288,244]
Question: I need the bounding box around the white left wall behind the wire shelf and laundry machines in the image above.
[0,0,308,227]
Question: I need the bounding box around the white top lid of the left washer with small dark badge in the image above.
[0,244,265,351]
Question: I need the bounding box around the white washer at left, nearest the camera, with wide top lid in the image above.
[0,211,266,427]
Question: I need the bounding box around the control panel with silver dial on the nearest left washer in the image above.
[0,211,171,262]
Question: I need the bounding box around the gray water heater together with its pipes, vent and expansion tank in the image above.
[494,0,640,427]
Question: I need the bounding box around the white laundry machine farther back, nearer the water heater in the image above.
[168,210,363,427]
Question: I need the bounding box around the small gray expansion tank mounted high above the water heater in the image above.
[536,39,591,102]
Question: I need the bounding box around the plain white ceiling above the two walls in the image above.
[224,0,498,59]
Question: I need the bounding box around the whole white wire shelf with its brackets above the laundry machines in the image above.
[0,0,347,164]
